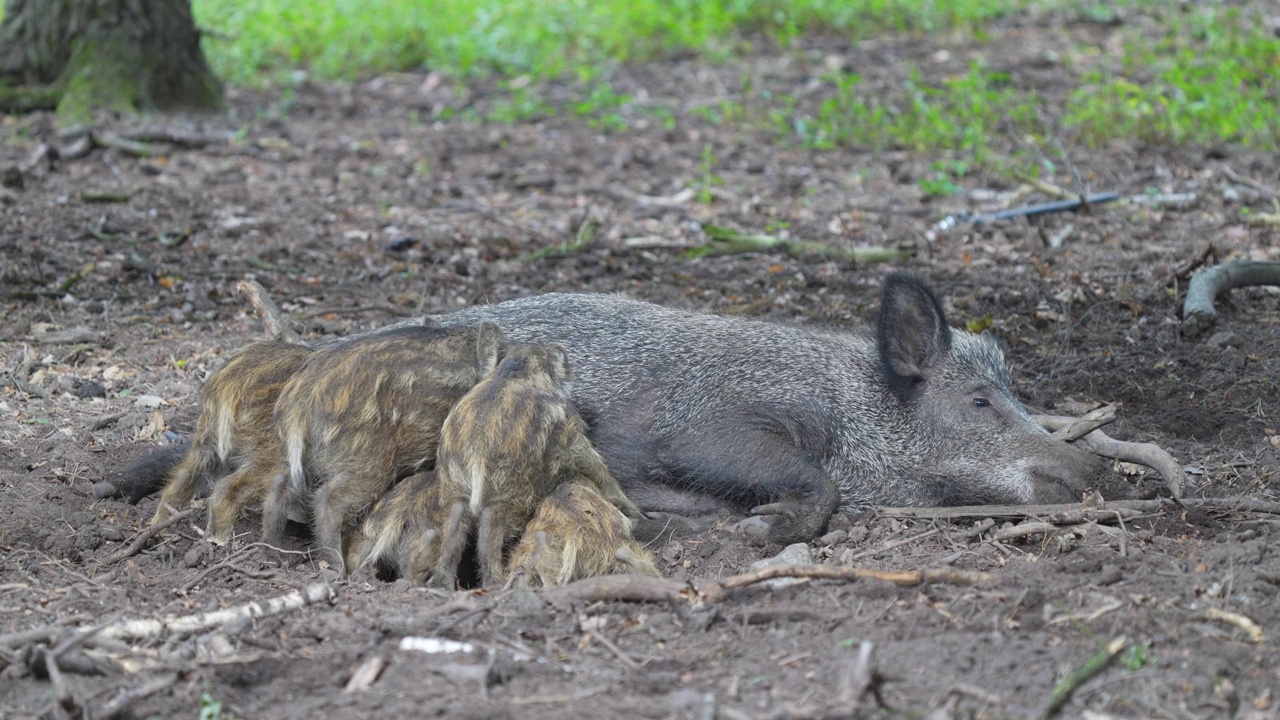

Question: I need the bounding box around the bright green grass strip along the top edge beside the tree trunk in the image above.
[192,0,1028,85]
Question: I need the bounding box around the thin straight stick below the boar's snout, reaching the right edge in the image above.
[876,497,1280,517]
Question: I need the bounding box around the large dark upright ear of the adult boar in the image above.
[876,273,951,389]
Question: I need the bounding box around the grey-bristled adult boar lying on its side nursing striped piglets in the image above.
[115,273,1102,543]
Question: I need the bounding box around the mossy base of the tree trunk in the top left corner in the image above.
[0,0,223,126]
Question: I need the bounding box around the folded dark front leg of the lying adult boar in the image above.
[662,427,840,544]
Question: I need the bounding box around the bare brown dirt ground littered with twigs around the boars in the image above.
[0,18,1280,719]
